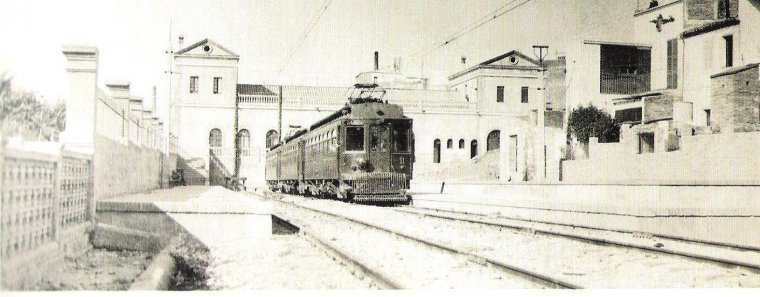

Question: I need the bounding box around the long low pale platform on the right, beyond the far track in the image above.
[410,182,760,250]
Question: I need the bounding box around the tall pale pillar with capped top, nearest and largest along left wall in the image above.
[60,45,98,154]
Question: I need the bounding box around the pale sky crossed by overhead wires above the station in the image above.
[0,0,637,118]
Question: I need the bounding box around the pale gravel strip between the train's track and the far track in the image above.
[284,196,760,288]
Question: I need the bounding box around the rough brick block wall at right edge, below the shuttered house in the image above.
[710,64,760,133]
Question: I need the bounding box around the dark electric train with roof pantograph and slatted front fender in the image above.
[265,84,414,204]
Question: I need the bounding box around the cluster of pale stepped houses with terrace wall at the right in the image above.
[563,0,760,184]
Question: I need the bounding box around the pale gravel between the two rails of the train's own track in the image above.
[275,199,546,289]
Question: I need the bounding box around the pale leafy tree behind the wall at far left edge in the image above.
[0,74,66,141]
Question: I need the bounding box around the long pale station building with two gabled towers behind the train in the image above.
[169,39,565,185]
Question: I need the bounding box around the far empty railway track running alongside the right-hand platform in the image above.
[394,206,760,271]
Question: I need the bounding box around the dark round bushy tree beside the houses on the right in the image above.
[567,105,620,144]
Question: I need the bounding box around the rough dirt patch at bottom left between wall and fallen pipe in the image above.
[35,249,152,291]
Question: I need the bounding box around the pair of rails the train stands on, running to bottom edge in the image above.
[272,193,582,289]
